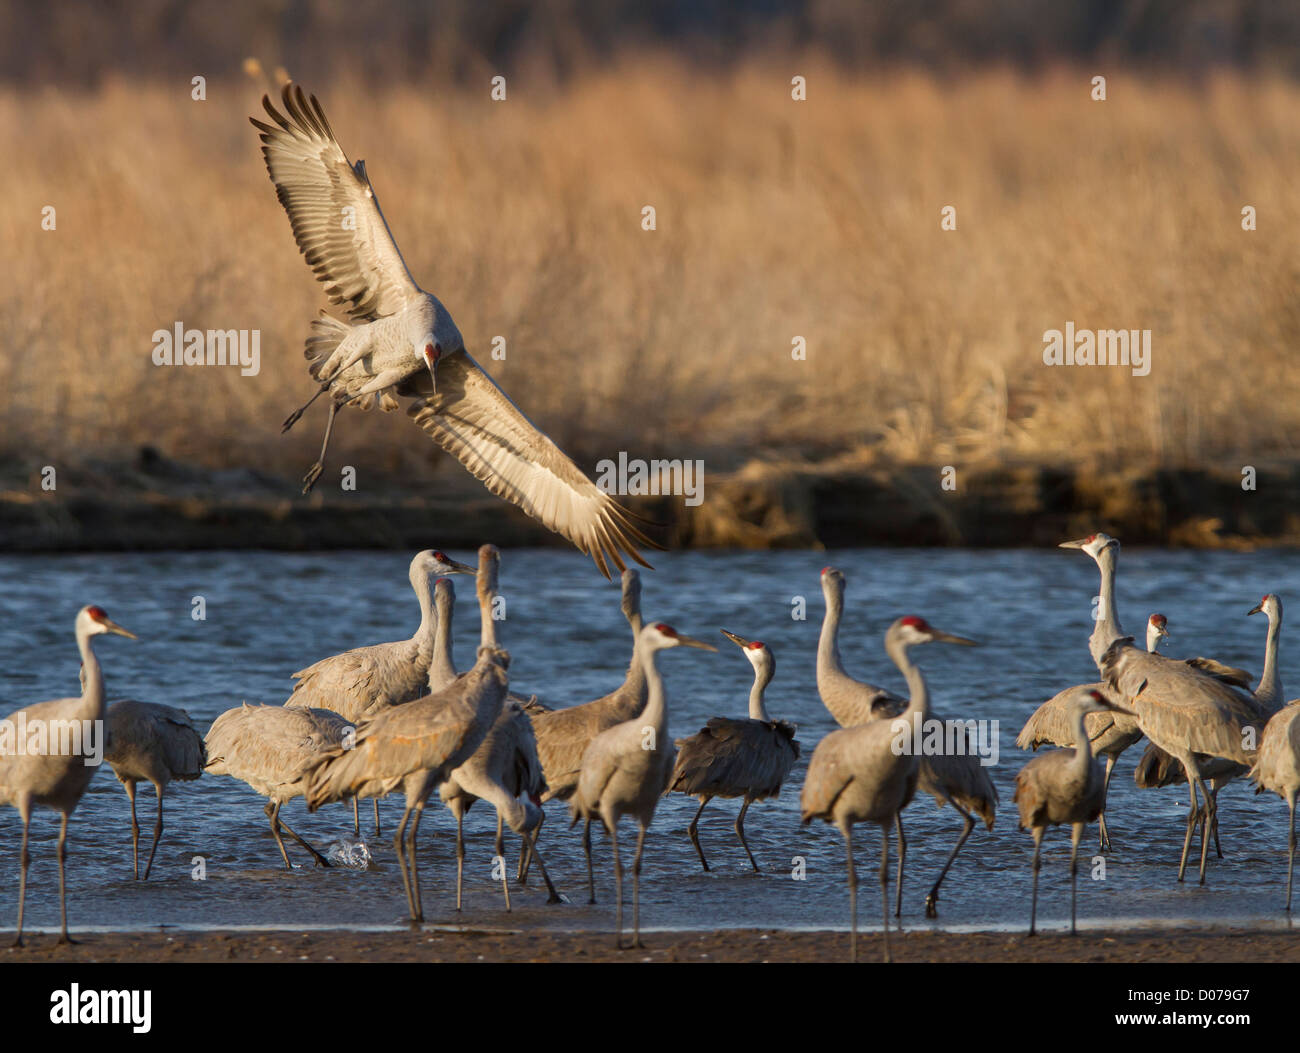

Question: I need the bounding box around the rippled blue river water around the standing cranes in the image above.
[0,540,1300,930]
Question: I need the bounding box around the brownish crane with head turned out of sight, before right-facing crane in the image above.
[304,647,510,923]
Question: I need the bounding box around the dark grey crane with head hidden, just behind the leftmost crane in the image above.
[104,698,208,881]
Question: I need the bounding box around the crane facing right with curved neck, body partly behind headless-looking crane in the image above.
[285,549,475,833]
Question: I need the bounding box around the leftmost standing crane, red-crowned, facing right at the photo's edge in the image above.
[0,606,135,946]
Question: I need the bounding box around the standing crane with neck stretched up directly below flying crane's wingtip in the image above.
[520,569,647,889]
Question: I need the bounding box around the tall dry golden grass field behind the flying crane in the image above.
[0,61,1300,472]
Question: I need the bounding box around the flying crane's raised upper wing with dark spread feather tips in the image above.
[248,85,421,321]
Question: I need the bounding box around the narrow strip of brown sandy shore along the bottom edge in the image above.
[0,928,1300,963]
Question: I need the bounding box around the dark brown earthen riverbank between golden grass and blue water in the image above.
[0,450,1300,553]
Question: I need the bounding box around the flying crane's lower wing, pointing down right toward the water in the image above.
[407,350,660,577]
